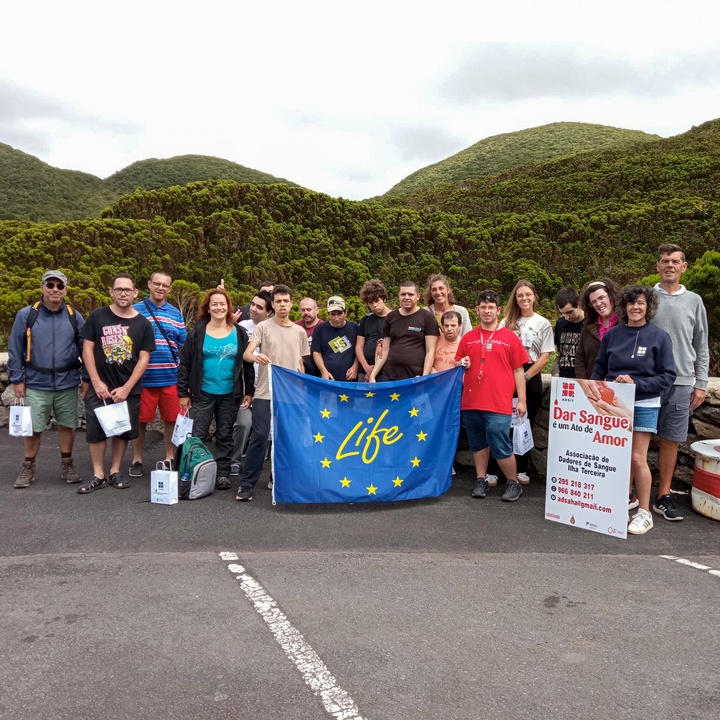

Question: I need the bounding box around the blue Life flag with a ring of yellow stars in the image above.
[271,366,462,503]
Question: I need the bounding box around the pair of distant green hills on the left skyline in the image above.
[0,143,294,222]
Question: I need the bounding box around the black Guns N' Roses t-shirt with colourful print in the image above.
[80,306,155,395]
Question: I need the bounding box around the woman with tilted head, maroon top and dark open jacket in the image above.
[575,280,621,380]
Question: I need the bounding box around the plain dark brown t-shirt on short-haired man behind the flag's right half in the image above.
[383,308,440,380]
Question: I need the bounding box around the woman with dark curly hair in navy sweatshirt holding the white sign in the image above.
[591,285,676,535]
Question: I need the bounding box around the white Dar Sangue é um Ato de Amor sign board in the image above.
[545,377,635,538]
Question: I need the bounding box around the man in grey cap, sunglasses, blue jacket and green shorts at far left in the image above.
[8,270,87,488]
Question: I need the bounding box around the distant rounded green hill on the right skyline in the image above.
[380,122,660,201]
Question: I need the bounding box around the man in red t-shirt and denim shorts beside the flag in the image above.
[455,290,528,502]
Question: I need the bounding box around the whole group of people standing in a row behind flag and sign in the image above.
[8,245,709,533]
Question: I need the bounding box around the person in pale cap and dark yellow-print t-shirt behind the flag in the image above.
[312,295,359,381]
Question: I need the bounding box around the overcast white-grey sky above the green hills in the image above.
[0,0,720,199]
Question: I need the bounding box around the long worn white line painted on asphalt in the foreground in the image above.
[220,552,363,720]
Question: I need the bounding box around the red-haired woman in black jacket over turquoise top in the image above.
[178,288,255,490]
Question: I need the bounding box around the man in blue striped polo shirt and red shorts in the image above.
[128,271,186,477]
